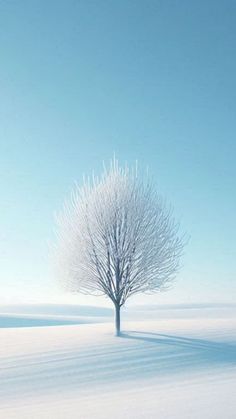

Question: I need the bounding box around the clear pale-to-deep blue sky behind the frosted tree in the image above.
[0,0,236,304]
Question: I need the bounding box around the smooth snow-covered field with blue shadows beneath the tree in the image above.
[0,306,236,419]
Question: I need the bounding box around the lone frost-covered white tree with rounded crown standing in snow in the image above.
[54,160,183,335]
